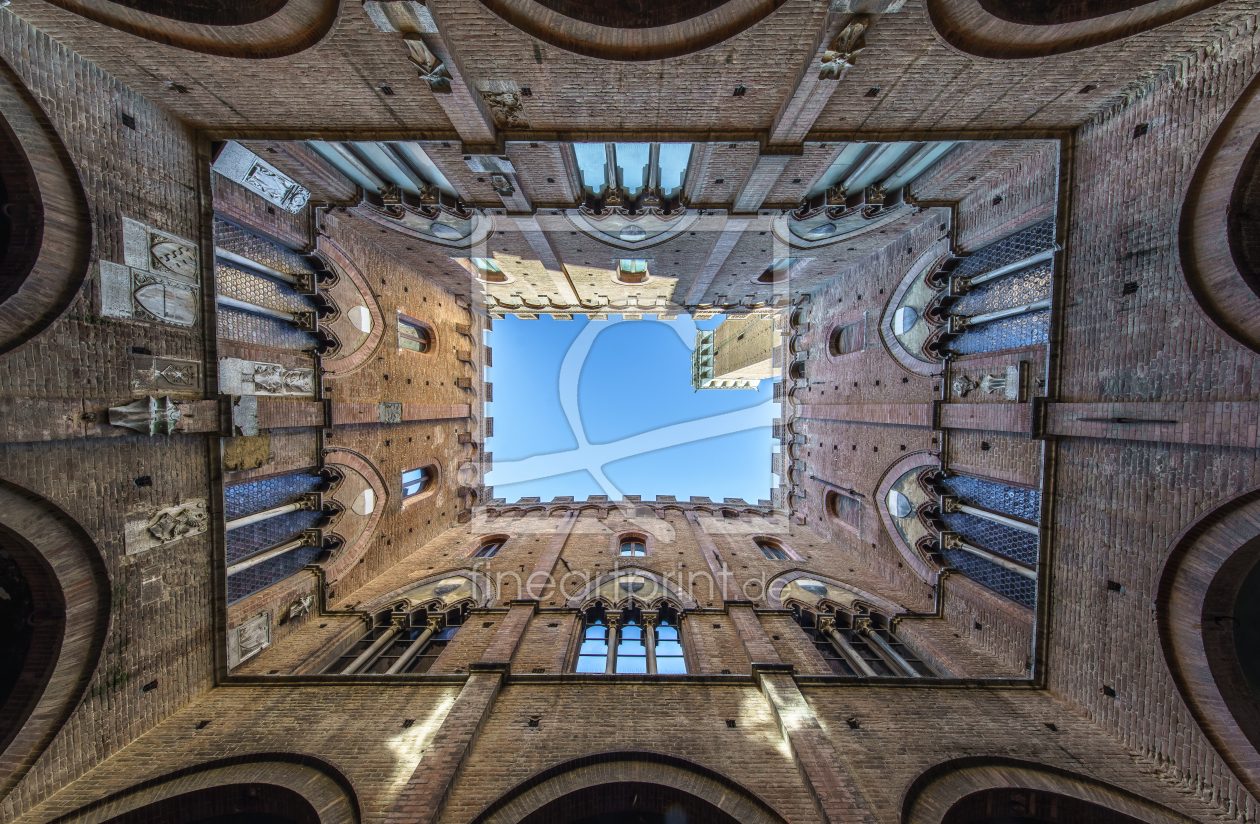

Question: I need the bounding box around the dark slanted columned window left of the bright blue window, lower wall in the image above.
[324,604,469,675]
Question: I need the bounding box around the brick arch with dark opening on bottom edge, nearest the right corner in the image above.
[901,757,1193,824]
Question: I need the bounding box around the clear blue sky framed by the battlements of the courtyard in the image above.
[486,315,779,503]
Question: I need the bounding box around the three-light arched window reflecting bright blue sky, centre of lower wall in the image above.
[577,607,687,675]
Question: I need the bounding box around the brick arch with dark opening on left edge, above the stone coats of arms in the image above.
[0,54,92,353]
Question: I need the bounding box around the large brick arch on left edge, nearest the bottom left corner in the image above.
[0,481,110,798]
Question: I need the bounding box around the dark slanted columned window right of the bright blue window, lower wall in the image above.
[791,605,936,678]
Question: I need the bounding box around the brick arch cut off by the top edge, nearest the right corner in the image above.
[927,0,1220,59]
